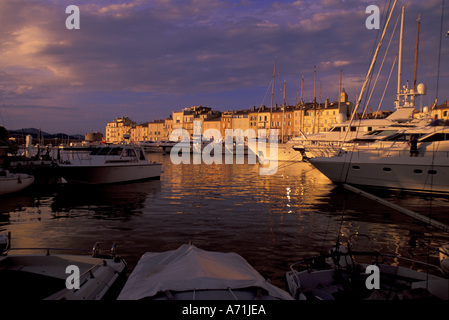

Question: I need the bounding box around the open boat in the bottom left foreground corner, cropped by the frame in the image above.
[0,233,127,301]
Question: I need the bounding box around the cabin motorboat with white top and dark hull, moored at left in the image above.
[58,145,162,184]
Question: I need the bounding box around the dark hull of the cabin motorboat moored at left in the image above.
[60,163,162,185]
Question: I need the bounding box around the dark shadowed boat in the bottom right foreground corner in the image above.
[286,235,449,301]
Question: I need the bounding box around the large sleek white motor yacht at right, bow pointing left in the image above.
[309,127,449,193]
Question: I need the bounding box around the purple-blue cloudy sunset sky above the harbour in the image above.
[0,0,449,134]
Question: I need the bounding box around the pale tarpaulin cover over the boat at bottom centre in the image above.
[118,244,292,300]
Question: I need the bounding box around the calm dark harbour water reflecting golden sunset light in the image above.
[0,154,449,289]
